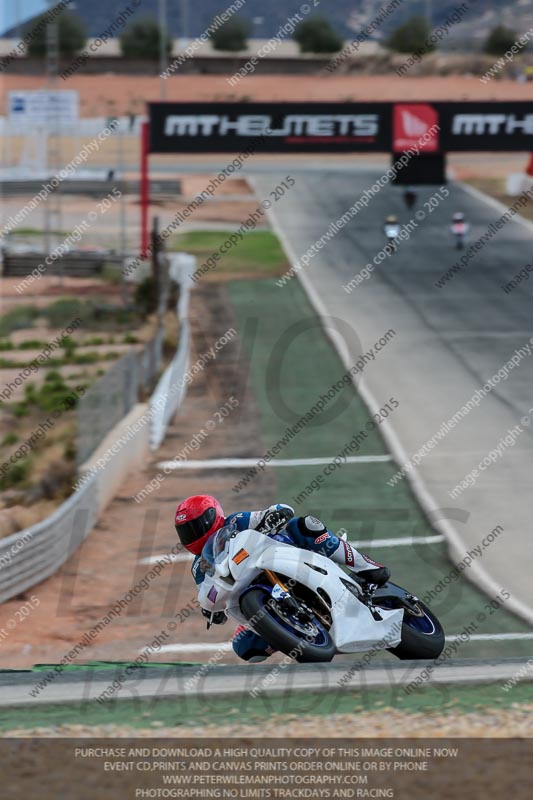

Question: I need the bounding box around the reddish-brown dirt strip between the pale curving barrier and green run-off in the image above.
[0,282,273,668]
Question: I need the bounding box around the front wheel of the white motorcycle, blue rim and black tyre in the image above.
[241,587,336,664]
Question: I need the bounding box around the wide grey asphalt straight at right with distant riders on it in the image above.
[254,167,533,621]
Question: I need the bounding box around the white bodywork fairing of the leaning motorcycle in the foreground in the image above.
[198,530,404,653]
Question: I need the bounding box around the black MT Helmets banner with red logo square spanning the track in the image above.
[149,102,533,154]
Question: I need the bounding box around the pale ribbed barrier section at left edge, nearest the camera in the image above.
[0,477,98,603]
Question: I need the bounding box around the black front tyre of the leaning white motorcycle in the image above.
[241,587,336,664]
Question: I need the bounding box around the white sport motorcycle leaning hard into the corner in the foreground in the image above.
[198,523,445,662]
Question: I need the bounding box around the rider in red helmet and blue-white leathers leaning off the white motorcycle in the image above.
[174,495,391,662]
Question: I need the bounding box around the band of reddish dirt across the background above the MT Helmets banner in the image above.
[0,74,531,117]
